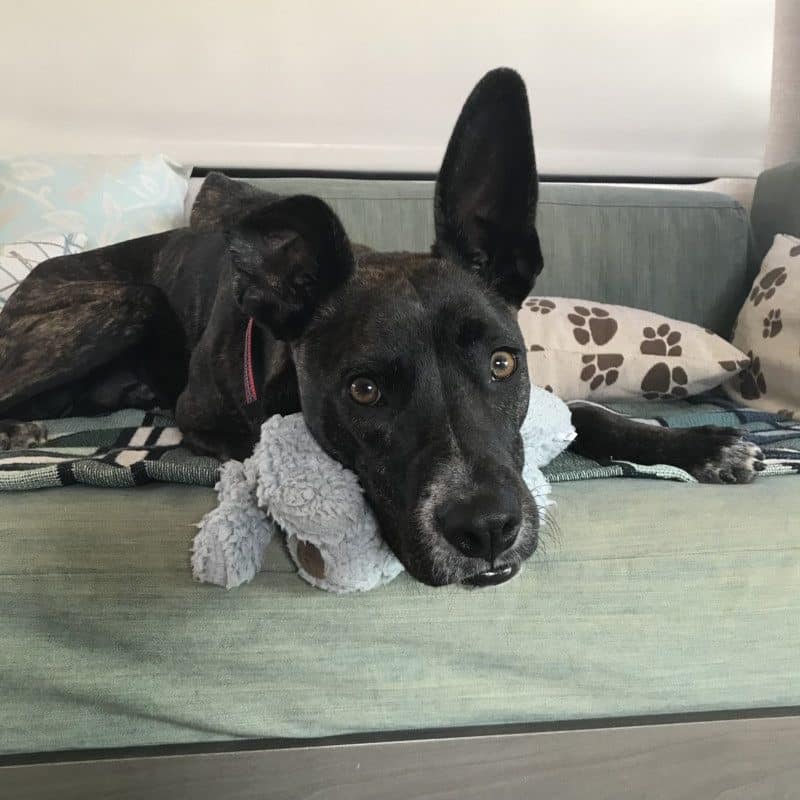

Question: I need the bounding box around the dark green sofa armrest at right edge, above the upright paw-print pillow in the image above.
[750,161,800,264]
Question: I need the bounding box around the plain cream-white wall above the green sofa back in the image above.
[0,0,773,176]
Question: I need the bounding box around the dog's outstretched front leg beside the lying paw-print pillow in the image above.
[569,402,764,483]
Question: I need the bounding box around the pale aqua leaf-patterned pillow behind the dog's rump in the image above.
[0,155,191,248]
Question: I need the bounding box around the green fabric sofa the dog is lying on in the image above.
[0,167,800,768]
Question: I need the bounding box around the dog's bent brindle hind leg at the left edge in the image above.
[0,281,178,420]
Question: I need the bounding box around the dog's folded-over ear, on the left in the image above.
[226,195,354,341]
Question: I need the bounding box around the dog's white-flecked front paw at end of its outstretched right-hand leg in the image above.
[686,425,764,483]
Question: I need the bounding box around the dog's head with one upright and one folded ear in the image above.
[231,69,542,585]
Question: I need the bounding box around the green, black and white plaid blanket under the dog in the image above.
[0,396,800,491]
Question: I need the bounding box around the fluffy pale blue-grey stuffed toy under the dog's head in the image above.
[191,386,575,593]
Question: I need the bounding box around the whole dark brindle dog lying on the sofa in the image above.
[0,69,762,585]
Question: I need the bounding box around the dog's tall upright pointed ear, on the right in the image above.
[434,69,542,306]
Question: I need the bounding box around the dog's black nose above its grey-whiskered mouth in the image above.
[436,491,520,563]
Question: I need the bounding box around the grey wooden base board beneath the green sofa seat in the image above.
[0,711,800,800]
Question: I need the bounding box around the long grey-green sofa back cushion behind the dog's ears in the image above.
[236,178,753,336]
